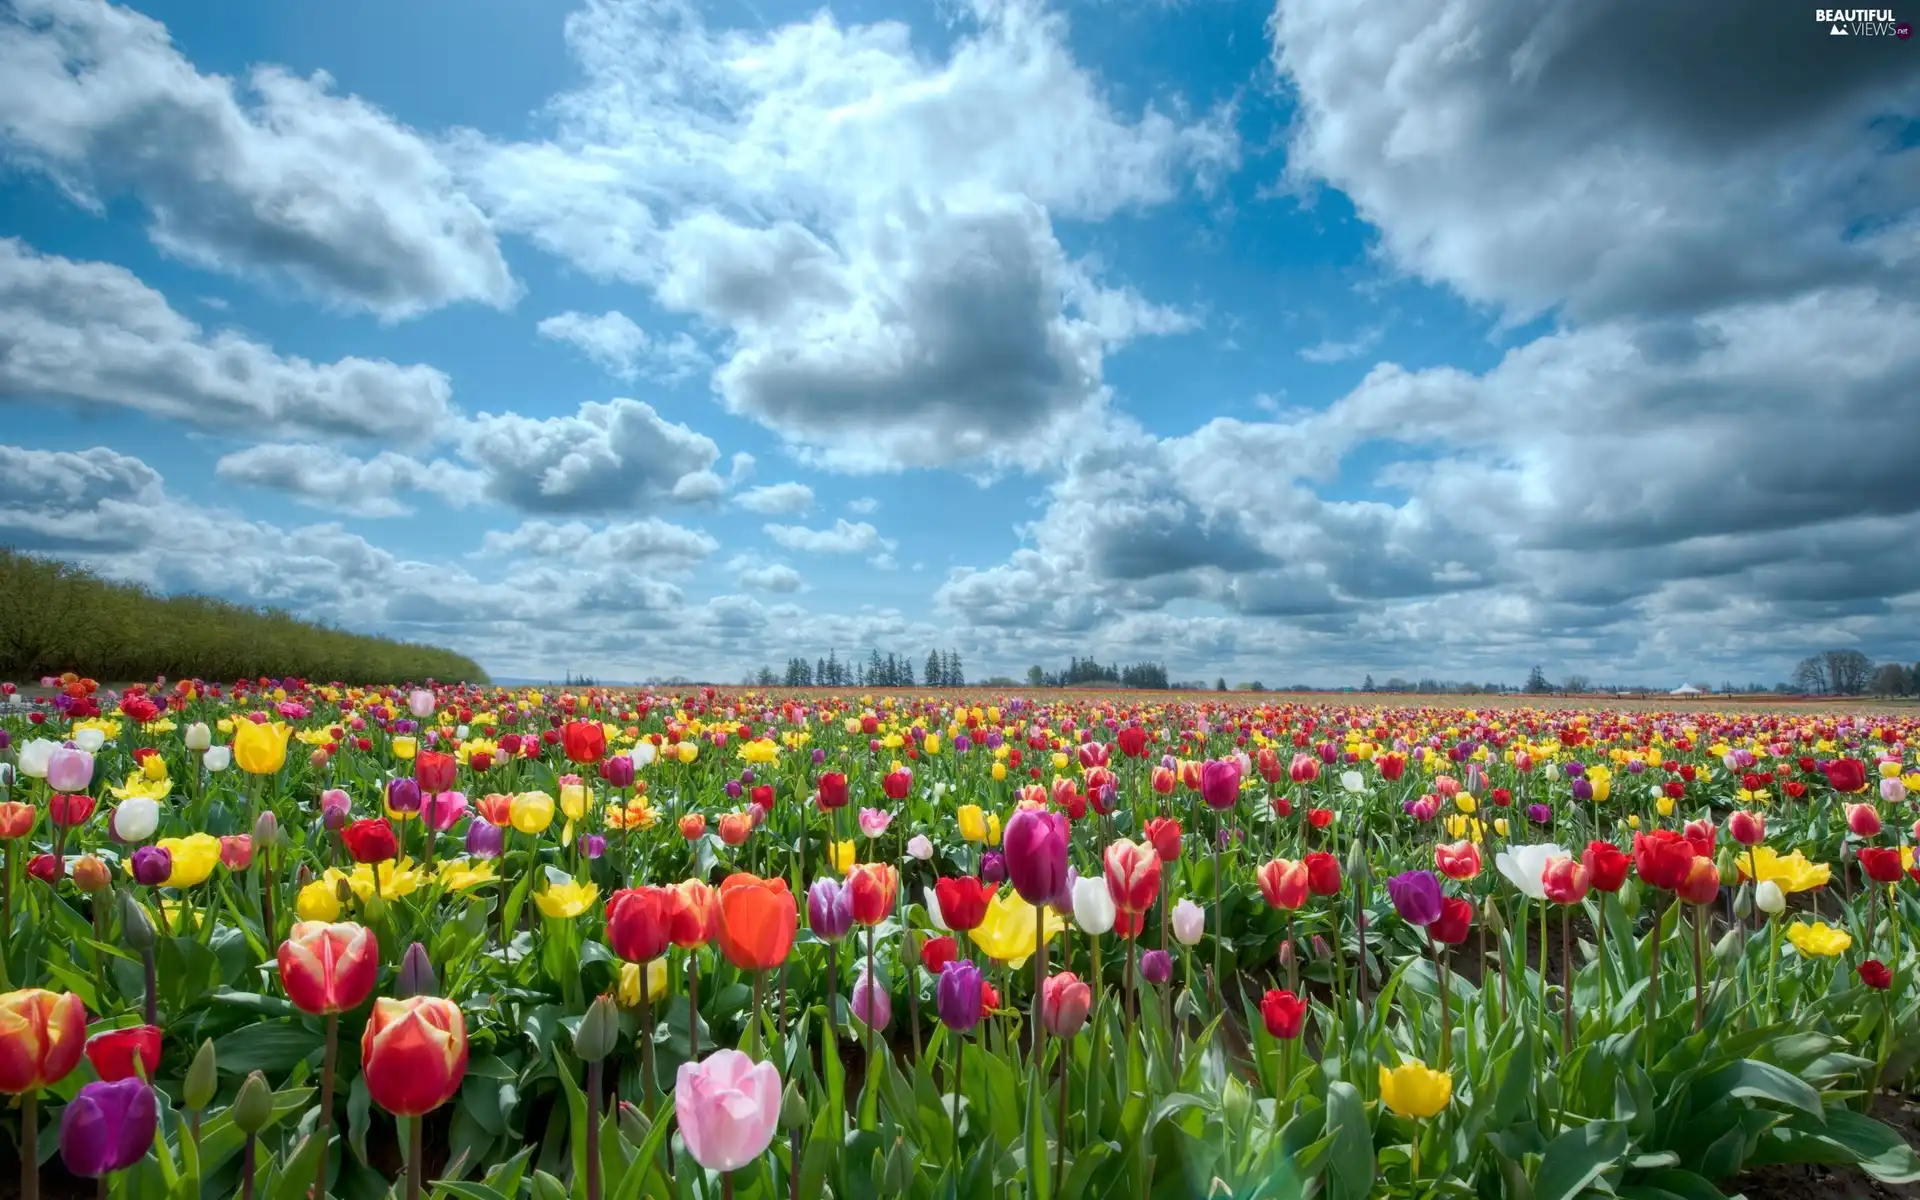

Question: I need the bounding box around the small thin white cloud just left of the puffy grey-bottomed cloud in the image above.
[213,444,484,516]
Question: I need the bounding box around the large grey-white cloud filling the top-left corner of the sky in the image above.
[0,0,516,319]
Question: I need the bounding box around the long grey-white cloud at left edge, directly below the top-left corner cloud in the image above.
[0,238,453,444]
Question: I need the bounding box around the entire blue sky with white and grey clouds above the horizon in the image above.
[0,0,1920,685]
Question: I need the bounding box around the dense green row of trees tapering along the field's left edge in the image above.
[0,547,486,684]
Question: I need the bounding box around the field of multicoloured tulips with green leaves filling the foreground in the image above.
[0,676,1920,1200]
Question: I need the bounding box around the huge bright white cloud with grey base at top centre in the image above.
[461,0,1238,470]
